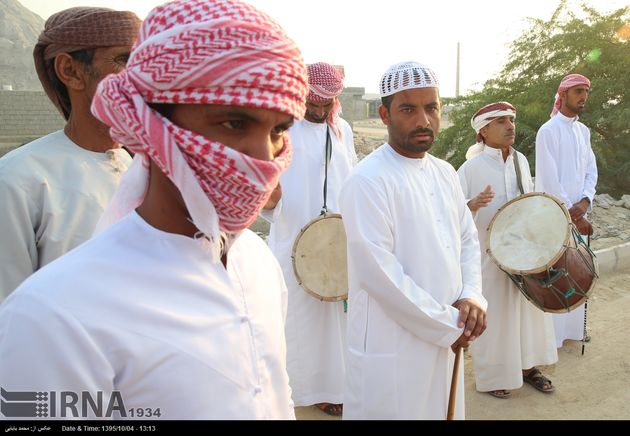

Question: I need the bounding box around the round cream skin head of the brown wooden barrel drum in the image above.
[488,192,571,274]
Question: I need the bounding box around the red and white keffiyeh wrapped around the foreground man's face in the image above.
[92,0,308,247]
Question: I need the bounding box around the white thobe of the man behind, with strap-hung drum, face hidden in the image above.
[263,120,357,406]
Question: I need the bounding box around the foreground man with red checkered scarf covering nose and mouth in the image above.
[0,0,307,419]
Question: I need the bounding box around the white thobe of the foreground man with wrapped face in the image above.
[0,212,295,419]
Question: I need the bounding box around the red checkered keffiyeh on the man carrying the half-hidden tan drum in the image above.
[306,62,343,138]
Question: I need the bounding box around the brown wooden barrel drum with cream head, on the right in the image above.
[486,192,599,313]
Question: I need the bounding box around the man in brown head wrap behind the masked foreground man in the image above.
[0,7,140,302]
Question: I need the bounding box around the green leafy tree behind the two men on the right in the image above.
[434,0,630,195]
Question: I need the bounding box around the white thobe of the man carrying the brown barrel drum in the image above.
[457,146,558,392]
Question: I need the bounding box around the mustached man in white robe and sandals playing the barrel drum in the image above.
[457,102,558,398]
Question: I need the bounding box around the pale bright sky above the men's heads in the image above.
[16,0,630,97]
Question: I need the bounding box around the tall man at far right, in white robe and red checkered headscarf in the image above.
[536,74,597,348]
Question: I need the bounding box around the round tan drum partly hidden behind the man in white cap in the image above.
[291,213,348,301]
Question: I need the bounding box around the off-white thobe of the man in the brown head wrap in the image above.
[0,131,131,302]
